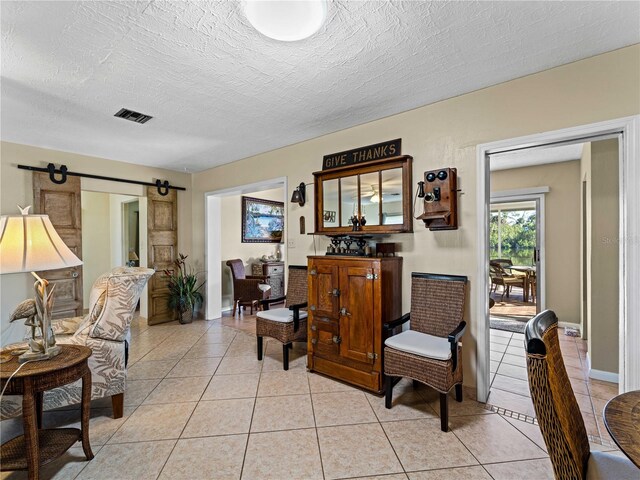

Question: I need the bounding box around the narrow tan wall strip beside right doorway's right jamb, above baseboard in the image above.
[588,139,619,374]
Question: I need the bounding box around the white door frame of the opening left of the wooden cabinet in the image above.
[204,177,289,319]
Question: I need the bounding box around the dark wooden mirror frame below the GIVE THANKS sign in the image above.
[313,155,413,235]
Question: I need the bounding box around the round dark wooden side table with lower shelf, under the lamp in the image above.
[0,345,93,480]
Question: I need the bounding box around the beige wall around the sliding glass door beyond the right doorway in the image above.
[491,160,580,323]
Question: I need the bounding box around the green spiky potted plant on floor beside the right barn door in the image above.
[164,253,205,323]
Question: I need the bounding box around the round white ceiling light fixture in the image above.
[242,0,327,42]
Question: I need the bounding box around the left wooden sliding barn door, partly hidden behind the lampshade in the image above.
[33,172,83,318]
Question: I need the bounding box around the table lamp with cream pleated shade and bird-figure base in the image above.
[0,207,82,363]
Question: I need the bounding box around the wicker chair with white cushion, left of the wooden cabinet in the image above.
[256,265,307,370]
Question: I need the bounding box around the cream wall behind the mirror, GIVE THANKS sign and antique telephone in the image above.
[191,45,640,385]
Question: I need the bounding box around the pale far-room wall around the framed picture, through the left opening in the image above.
[220,188,288,309]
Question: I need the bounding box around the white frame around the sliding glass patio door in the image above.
[489,191,549,312]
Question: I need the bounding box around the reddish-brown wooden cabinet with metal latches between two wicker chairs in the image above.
[307,256,402,393]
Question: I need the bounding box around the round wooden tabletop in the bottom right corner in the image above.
[604,390,640,468]
